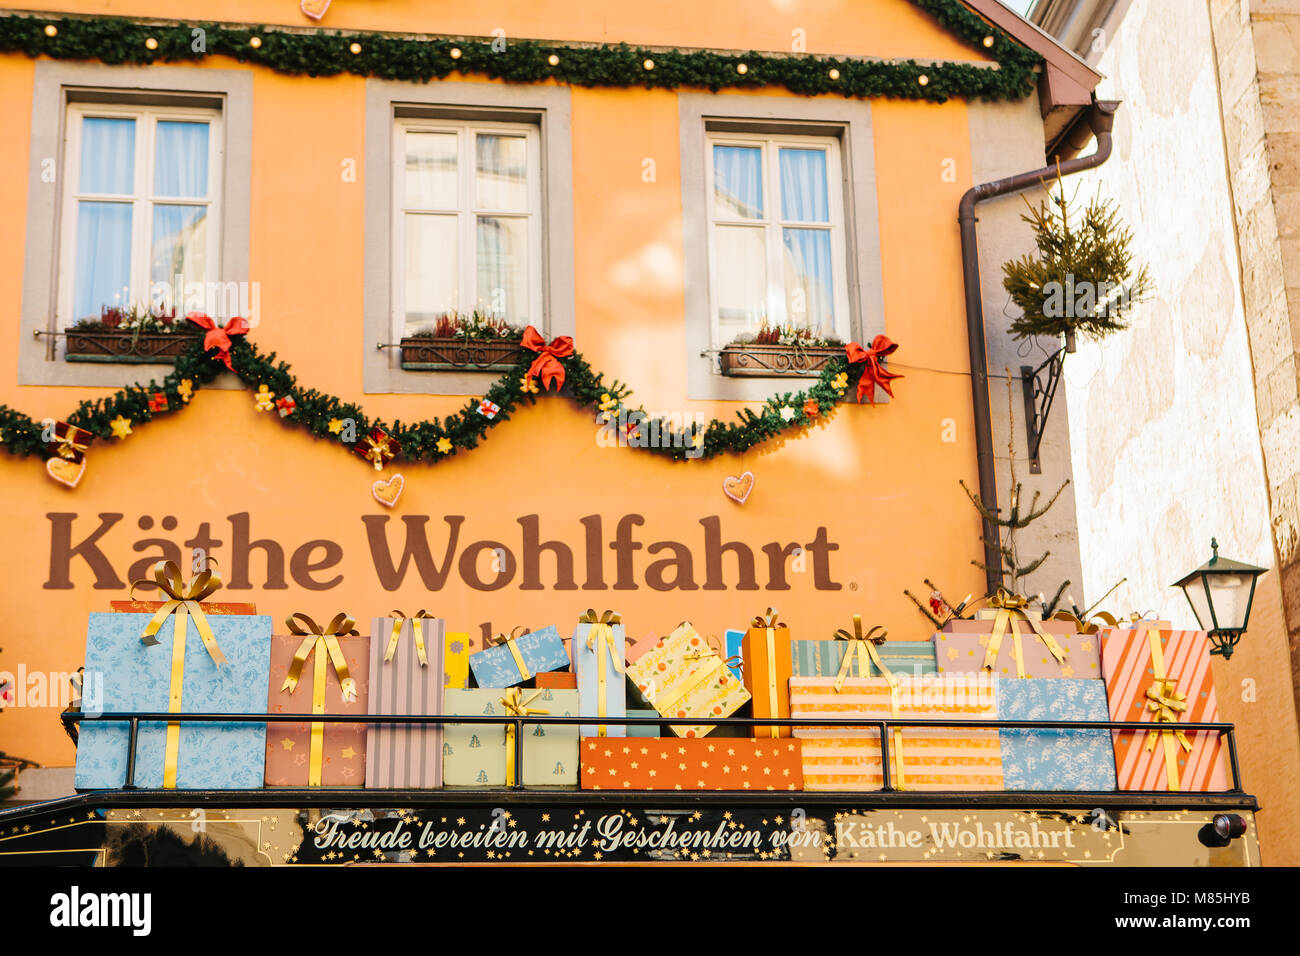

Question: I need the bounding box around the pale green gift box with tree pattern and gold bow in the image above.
[442,687,577,790]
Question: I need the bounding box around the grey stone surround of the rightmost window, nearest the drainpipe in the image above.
[677,92,888,402]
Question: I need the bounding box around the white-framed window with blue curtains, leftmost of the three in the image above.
[56,103,224,328]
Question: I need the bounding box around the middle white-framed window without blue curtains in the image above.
[393,117,542,338]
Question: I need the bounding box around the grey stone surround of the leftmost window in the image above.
[18,60,252,388]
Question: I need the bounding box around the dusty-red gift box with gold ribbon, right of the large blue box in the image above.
[267,633,371,787]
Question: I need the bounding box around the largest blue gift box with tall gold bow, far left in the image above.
[75,614,270,790]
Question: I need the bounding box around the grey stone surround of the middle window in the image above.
[361,79,575,395]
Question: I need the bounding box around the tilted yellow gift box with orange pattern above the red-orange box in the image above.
[628,622,749,737]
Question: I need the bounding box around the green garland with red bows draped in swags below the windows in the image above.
[0,336,883,462]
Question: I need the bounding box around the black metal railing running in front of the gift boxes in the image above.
[61,711,1242,793]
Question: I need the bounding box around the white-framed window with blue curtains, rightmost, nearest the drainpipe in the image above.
[706,131,850,347]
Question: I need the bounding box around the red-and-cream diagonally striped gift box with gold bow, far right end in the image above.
[1101,627,1231,792]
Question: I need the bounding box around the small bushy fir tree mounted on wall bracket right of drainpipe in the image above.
[1002,176,1151,351]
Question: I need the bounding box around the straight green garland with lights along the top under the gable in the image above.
[0,0,1040,103]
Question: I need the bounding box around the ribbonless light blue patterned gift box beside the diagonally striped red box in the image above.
[997,678,1115,791]
